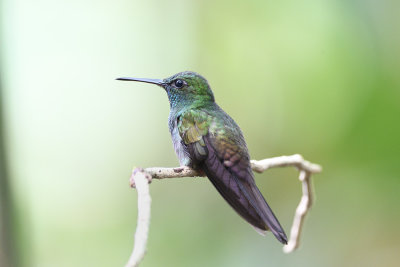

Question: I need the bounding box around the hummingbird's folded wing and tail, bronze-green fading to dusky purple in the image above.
[177,110,287,243]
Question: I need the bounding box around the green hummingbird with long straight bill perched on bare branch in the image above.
[117,71,287,244]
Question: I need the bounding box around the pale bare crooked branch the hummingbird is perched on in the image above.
[126,154,322,267]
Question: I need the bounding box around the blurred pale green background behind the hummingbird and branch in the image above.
[0,0,400,267]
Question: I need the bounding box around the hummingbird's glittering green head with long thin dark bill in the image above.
[117,71,214,108]
